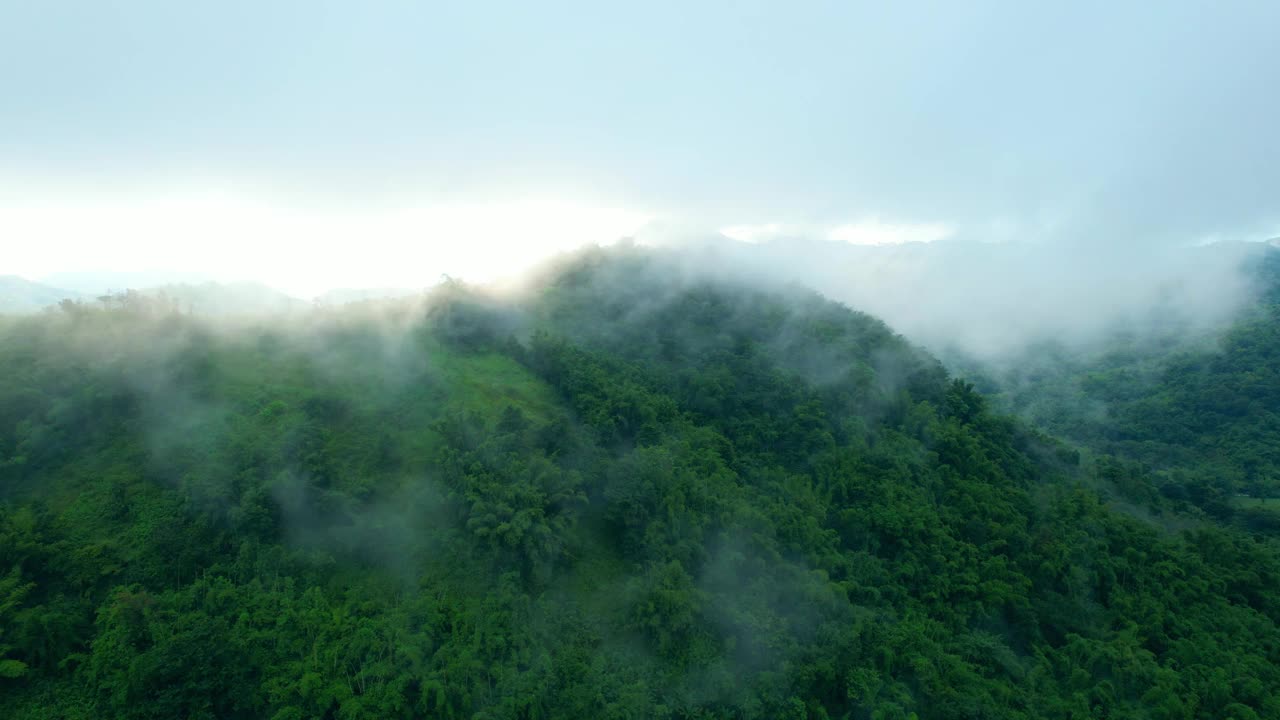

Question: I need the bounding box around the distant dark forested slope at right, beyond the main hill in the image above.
[970,250,1280,534]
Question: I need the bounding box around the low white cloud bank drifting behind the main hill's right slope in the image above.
[641,233,1275,360]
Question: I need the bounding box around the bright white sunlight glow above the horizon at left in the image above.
[0,192,649,297]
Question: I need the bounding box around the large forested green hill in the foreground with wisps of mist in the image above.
[0,244,1280,720]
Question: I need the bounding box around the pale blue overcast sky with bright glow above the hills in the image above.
[0,0,1280,295]
